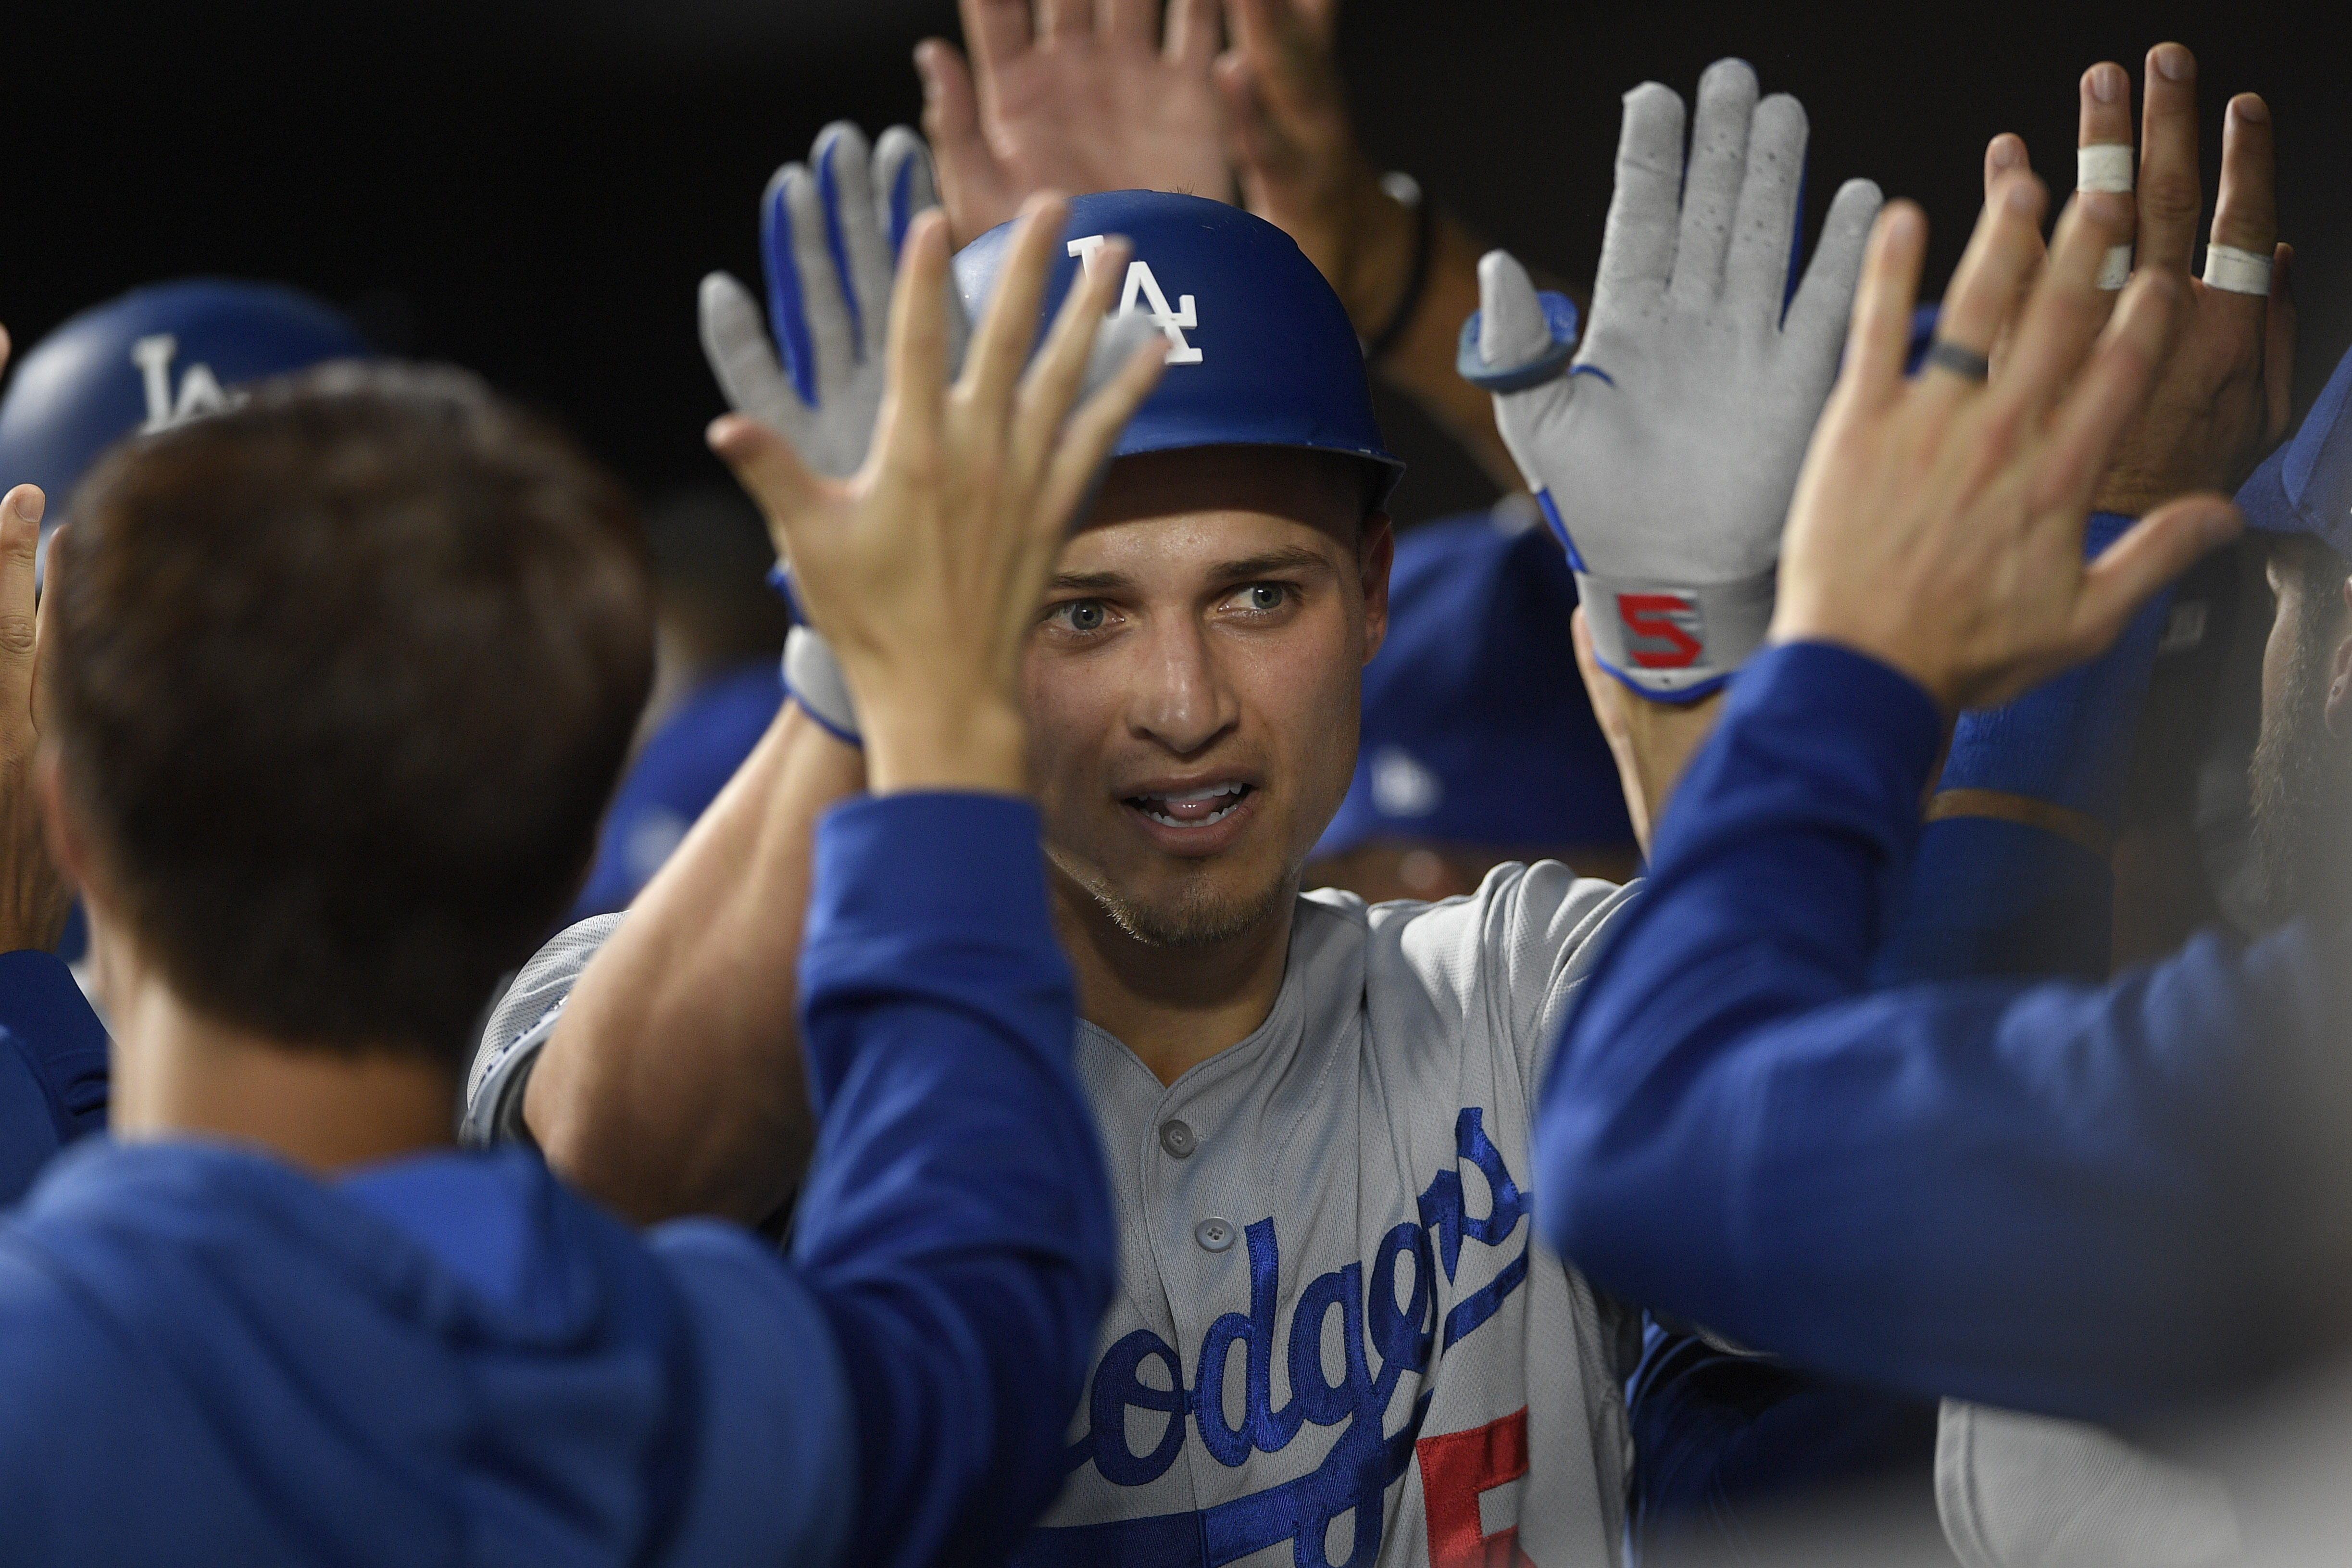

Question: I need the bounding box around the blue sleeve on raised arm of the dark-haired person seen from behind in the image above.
[793,795,1117,1568]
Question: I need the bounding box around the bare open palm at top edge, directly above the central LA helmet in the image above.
[915,0,1235,244]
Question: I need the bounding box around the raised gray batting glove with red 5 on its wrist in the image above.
[1463,61,1879,701]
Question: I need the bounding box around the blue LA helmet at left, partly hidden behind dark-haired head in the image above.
[0,277,374,534]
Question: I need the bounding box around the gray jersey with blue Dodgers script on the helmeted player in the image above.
[470,863,1637,1568]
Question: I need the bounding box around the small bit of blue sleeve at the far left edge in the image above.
[0,950,108,1206]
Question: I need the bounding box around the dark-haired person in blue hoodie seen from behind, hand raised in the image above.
[0,192,1157,1566]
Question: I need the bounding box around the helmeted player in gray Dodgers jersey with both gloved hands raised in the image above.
[487,61,1877,1566]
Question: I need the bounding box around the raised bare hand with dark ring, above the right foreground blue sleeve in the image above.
[1771,172,2239,712]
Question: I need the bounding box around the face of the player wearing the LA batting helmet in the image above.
[1026,447,1390,945]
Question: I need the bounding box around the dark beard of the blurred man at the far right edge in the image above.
[2249,637,2352,924]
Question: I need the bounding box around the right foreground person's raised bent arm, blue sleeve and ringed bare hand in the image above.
[1543,37,2345,1457]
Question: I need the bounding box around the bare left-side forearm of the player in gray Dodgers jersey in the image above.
[525,703,863,1222]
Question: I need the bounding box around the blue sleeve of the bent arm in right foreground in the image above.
[1538,644,2342,1420]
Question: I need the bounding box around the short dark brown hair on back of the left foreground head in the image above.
[45,364,654,1060]
